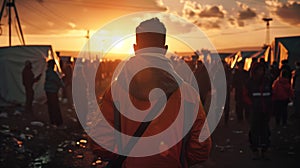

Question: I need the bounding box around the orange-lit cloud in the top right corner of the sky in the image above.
[266,1,300,26]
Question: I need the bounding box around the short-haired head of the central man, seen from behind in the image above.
[134,18,168,51]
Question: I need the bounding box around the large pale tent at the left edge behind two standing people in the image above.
[0,45,57,106]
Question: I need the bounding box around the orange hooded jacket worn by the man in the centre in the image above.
[91,54,211,168]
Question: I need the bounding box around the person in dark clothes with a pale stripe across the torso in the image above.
[243,63,272,160]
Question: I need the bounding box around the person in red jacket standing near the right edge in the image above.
[272,70,293,127]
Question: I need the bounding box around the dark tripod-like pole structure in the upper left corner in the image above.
[0,0,25,47]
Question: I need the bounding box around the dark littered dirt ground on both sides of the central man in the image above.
[0,94,300,168]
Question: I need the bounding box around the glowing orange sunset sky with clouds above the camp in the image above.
[0,0,300,51]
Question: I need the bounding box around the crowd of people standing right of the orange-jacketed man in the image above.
[188,58,300,159]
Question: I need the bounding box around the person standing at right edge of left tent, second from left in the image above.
[44,60,63,126]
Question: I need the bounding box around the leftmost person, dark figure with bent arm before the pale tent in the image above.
[22,61,42,113]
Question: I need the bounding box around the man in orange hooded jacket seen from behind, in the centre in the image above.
[89,18,211,168]
